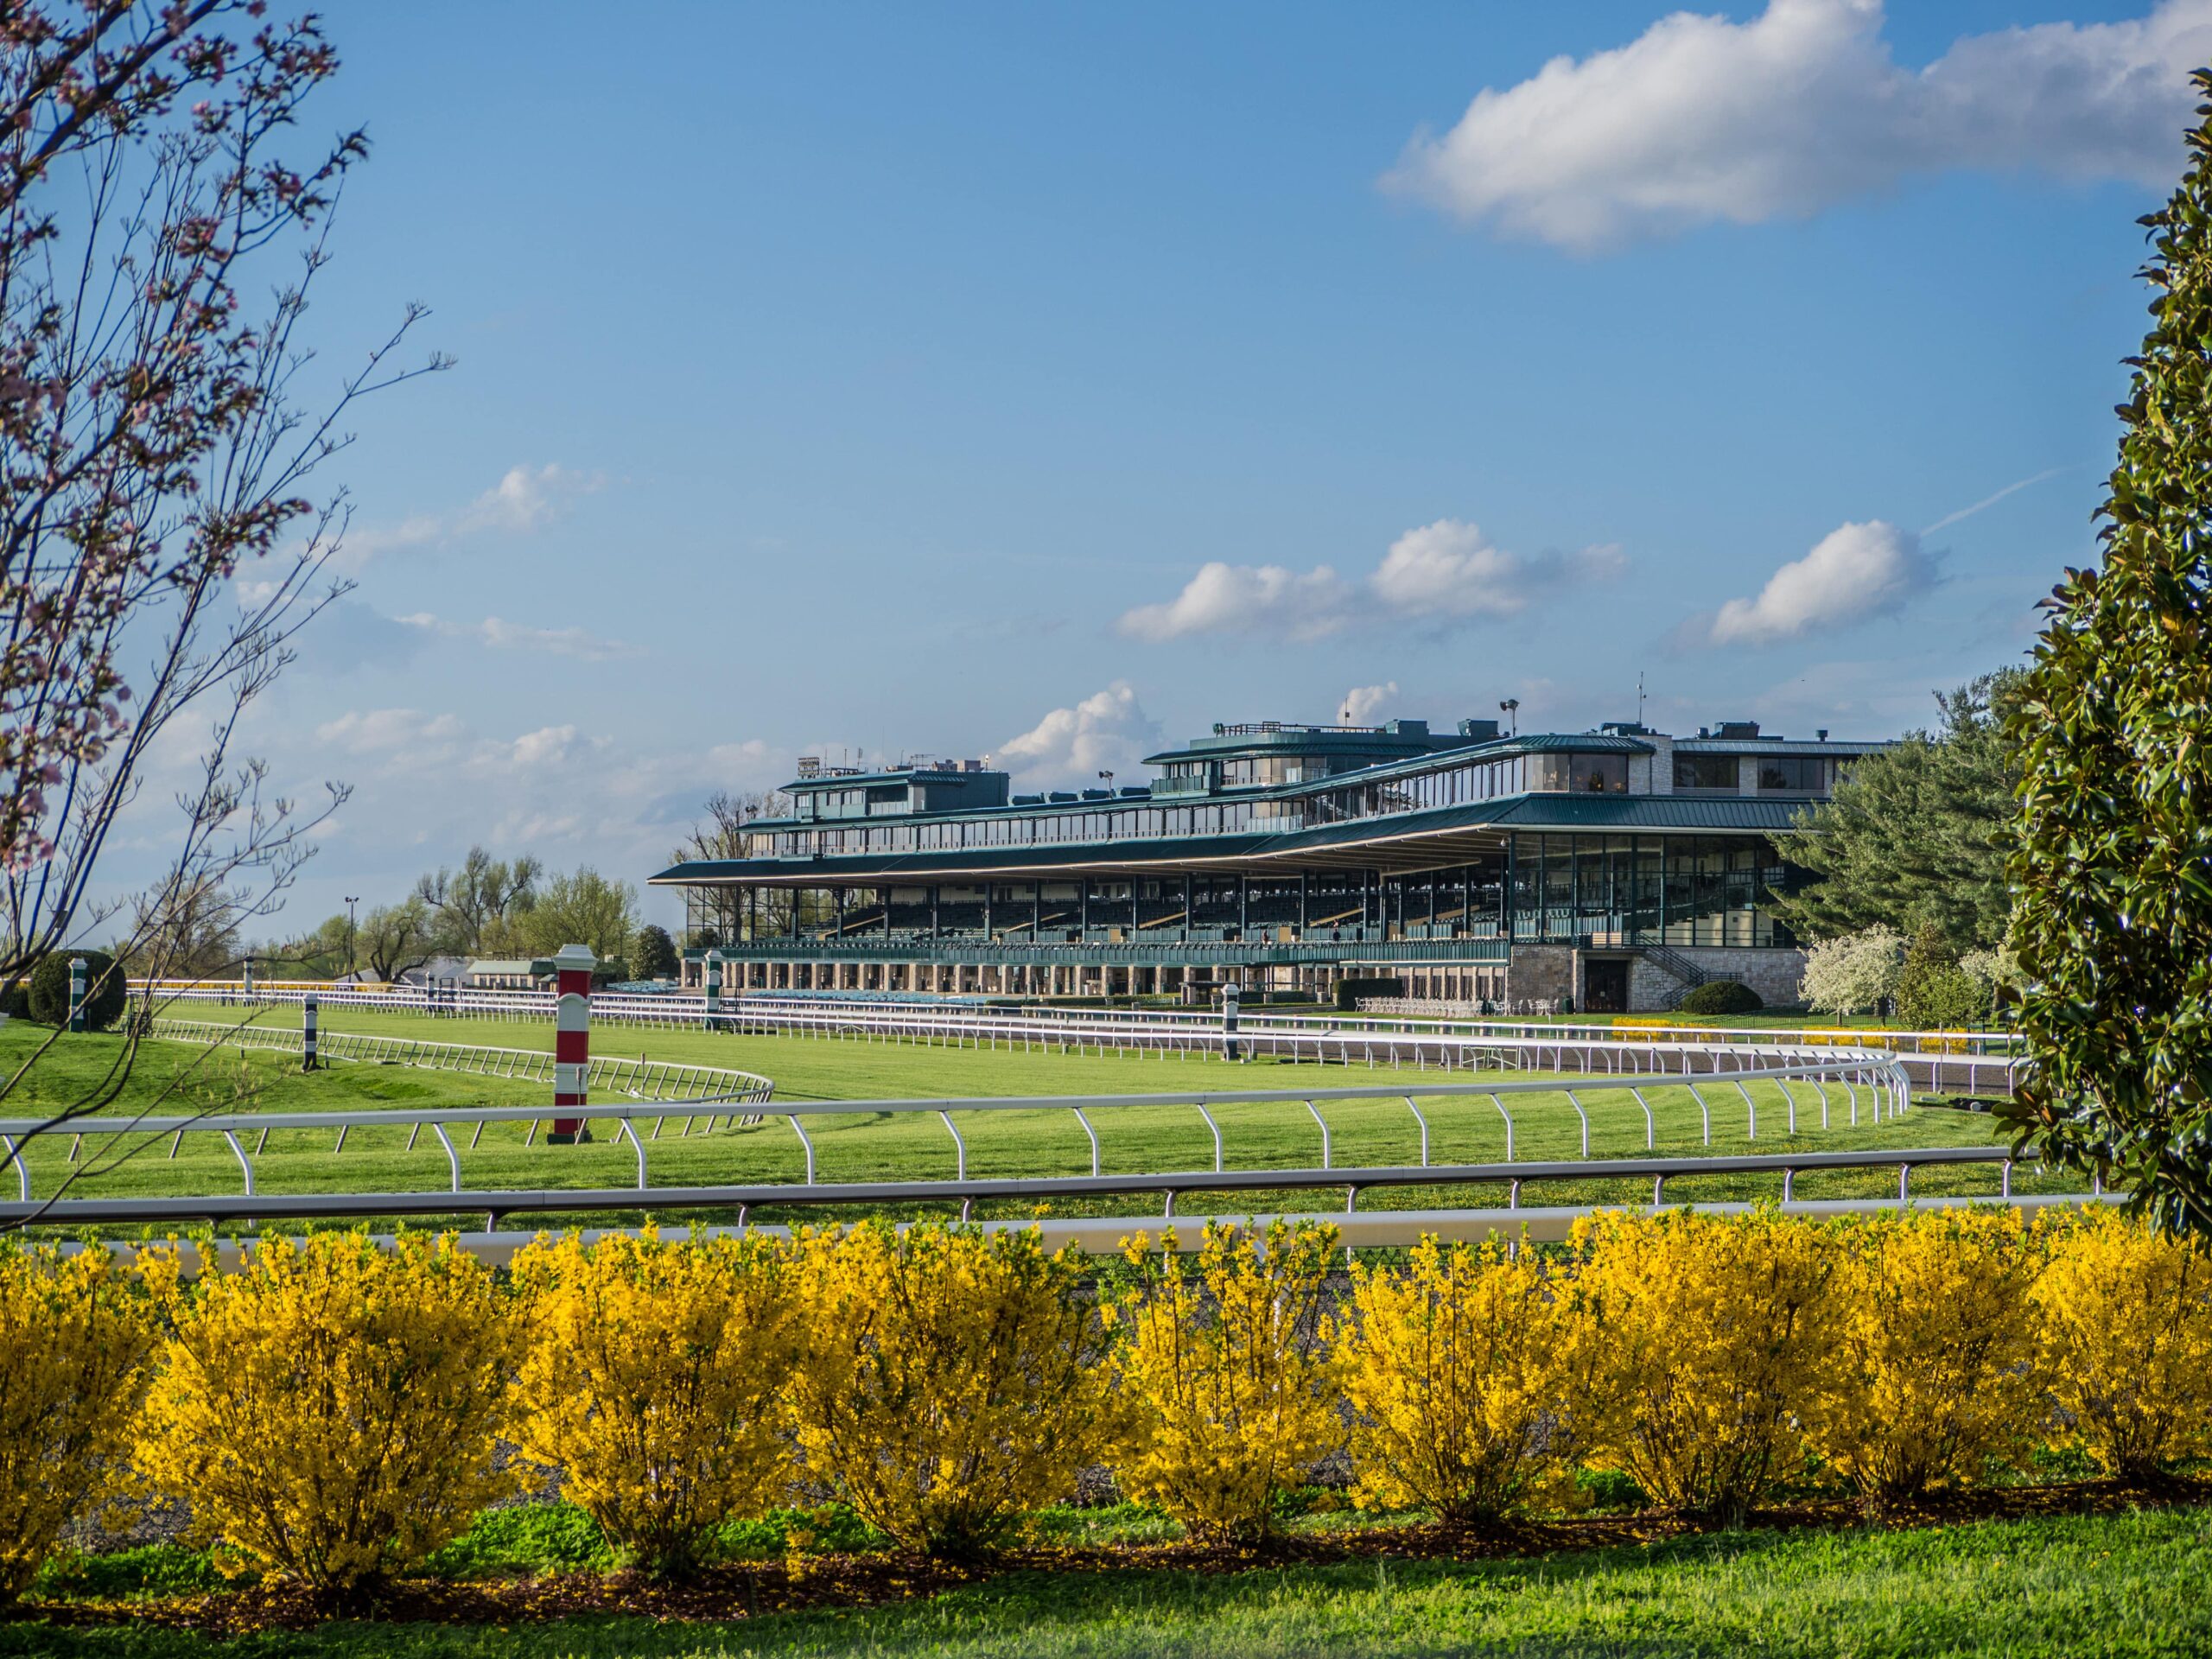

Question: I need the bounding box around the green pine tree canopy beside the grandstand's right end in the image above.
[1774,671,2022,951]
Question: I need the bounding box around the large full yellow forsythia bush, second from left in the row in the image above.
[137,1232,515,1601]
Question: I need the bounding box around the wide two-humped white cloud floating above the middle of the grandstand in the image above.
[1122,518,1626,641]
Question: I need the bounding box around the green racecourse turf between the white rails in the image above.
[0,1008,2025,1221]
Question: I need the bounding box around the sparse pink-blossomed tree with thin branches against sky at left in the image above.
[0,0,442,1000]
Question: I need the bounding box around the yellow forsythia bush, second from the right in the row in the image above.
[1814,1210,2042,1502]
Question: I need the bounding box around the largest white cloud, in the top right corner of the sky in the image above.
[1385,0,2212,252]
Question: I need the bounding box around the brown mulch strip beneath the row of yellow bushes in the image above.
[13,1480,2212,1637]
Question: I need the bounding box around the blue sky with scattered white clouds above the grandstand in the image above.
[147,0,2212,925]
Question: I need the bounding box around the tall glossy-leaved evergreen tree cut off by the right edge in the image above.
[2006,71,2212,1234]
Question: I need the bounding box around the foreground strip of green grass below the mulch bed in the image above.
[0,1509,2212,1659]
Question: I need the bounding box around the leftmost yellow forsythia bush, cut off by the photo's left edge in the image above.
[0,1241,153,1604]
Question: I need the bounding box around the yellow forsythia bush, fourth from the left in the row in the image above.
[787,1224,1115,1557]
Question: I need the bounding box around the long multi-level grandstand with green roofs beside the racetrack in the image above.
[652,719,1878,1013]
